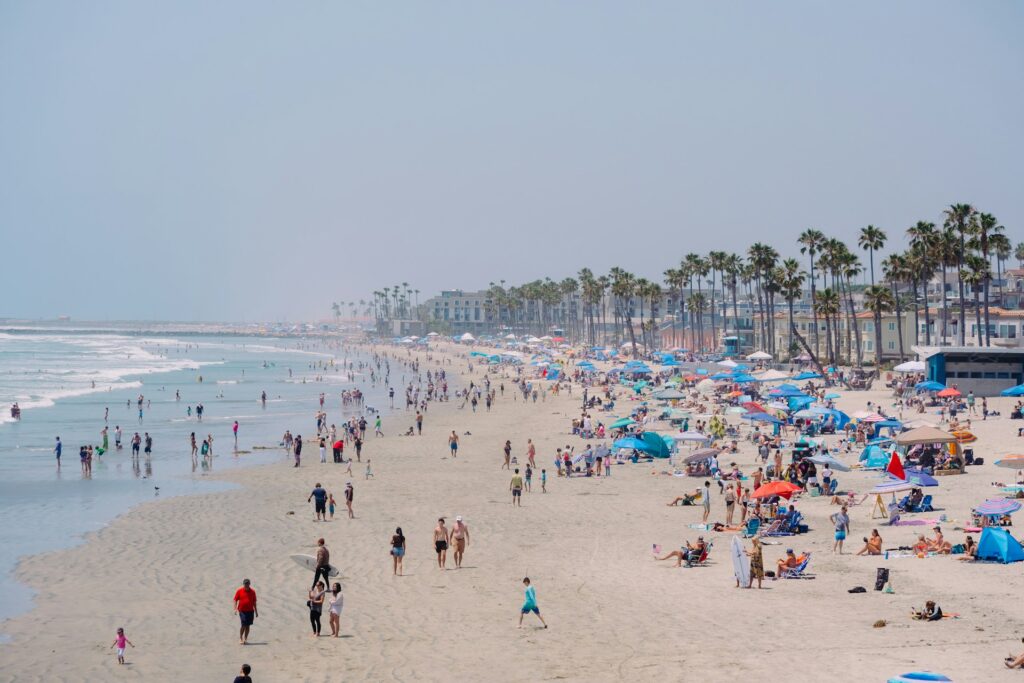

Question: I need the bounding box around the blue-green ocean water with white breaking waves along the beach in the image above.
[0,325,395,631]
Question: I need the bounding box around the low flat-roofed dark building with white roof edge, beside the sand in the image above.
[914,346,1024,396]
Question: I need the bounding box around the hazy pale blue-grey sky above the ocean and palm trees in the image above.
[0,0,1024,322]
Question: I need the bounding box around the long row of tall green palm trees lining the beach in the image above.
[360,204,1011,366]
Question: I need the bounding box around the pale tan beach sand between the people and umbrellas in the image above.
[0,349,1024,682]
